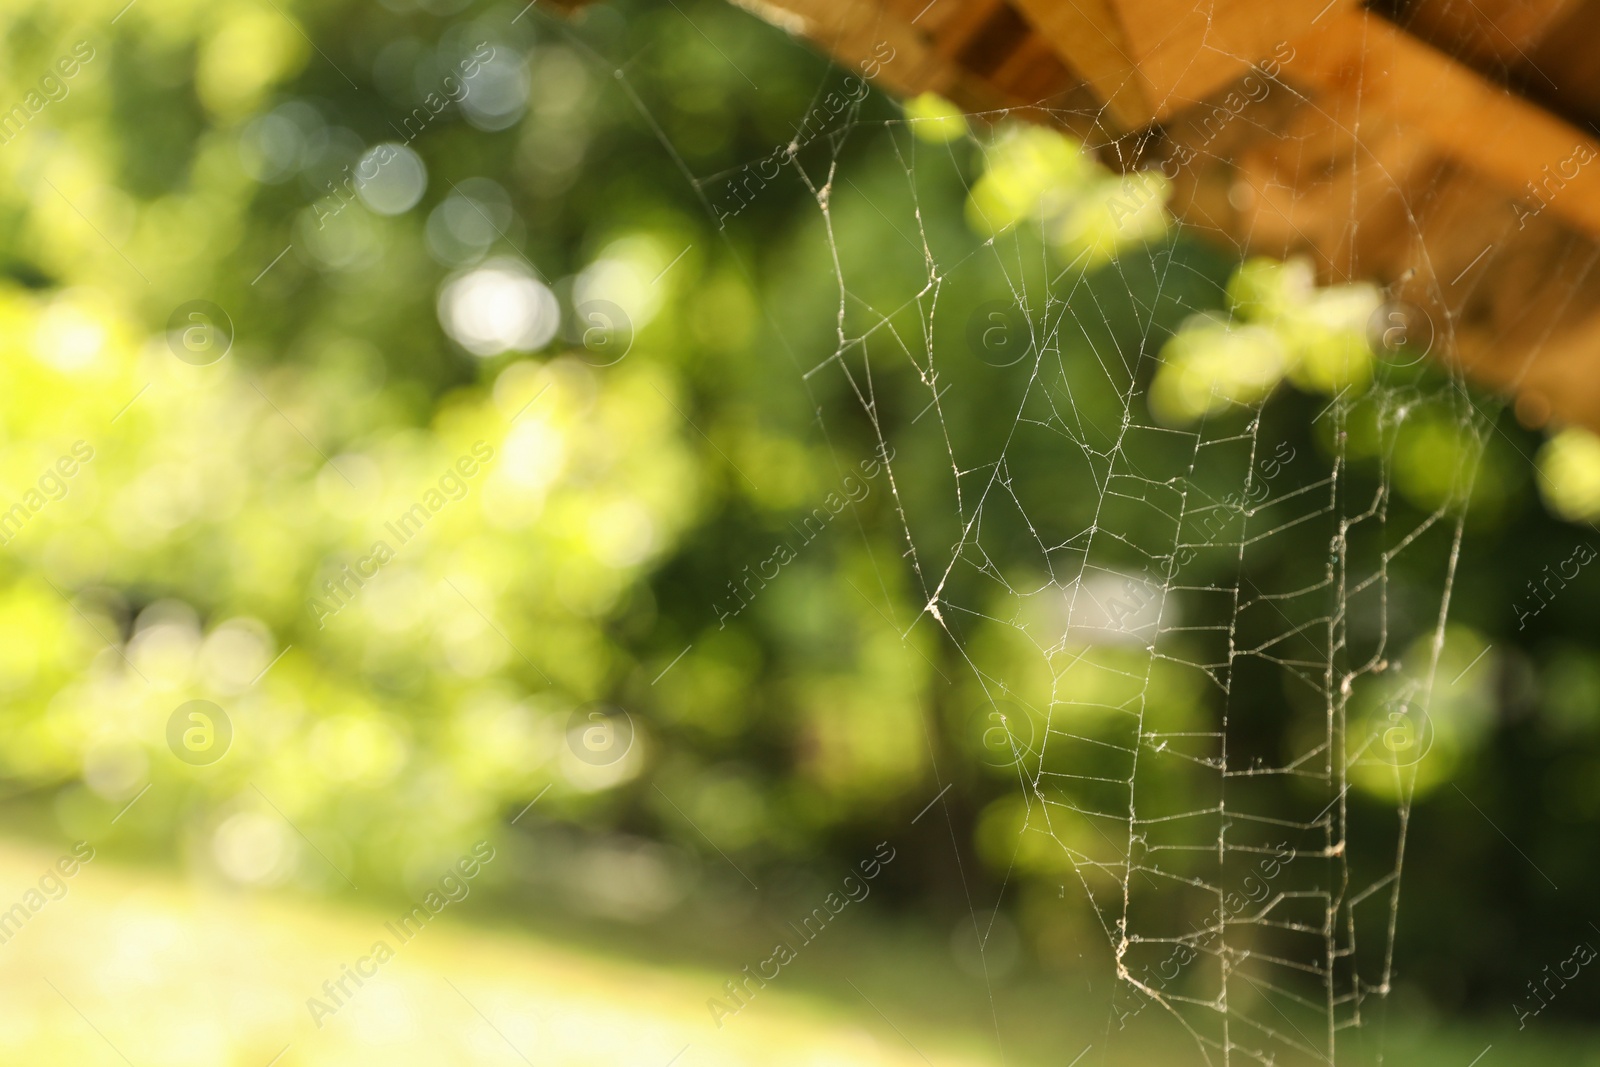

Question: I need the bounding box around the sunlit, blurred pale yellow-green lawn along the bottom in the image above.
[0,843,1600,1067]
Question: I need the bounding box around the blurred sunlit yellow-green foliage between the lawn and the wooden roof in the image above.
[0,0,1600,1030]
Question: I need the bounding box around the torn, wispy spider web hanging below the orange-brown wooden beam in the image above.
[585,4,1493,1064]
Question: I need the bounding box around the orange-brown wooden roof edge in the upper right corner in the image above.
[716,0,1600,429]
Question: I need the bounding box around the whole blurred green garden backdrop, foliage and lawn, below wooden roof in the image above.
[0,0,1600,1067]
